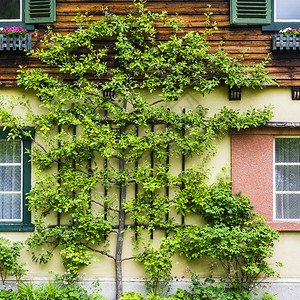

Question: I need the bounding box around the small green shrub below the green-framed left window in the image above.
[0,237,27,287]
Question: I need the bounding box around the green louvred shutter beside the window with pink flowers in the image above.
[25,0,56,24]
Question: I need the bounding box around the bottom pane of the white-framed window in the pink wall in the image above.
[276,194,300,219]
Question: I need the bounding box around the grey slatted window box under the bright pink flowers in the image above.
[0,34,32,51]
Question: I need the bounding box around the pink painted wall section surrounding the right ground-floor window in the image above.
[231,128,300,231]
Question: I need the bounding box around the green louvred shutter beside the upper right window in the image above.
[230,0,271,24]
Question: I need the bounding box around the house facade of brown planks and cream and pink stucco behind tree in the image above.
[0,0,300,299]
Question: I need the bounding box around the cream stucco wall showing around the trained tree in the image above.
[0,87,300,288]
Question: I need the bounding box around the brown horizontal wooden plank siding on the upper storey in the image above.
[0,0,300,86]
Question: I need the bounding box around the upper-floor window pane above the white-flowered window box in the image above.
[275,0,300,21]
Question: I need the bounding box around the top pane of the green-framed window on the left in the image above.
[0,141,21,163]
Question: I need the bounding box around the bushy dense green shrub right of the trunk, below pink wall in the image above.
[175,180,279,289]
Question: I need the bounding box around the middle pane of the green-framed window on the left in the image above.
[0,166,21,192]
